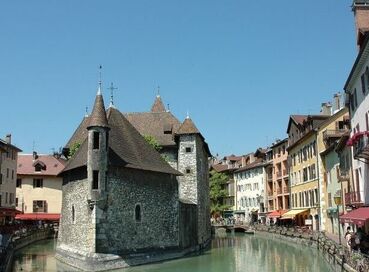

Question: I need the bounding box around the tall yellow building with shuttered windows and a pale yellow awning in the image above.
[282,115,329,230]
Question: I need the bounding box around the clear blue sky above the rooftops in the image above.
[0,0,358,156]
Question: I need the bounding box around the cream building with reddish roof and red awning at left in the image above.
[16,152,65,220]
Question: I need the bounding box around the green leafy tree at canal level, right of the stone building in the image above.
[210,170,230,215]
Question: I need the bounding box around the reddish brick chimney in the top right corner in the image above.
[352,0,369,51]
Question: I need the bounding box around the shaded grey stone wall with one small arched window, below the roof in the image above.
[96,168,179,254]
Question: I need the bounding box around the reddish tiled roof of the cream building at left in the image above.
[17,154,65,176]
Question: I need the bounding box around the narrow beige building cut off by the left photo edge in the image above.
[0,134,22,225]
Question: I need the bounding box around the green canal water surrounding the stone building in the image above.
[13,234,332,272]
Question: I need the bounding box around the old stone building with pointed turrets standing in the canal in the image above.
[56,87,210,270]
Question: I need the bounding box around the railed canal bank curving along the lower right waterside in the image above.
[255,226,369,272]
